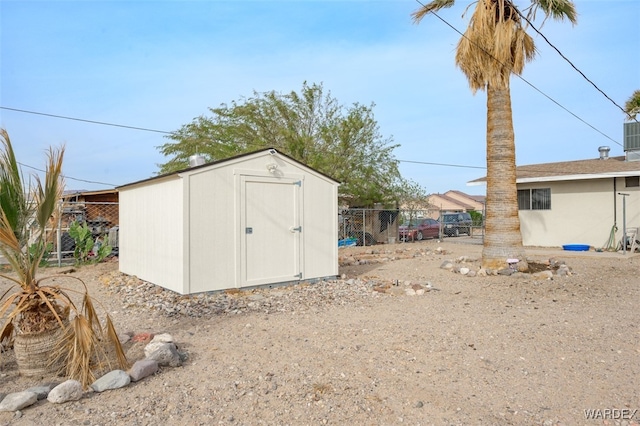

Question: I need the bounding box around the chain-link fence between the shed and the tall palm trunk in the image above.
[338,209,484,246]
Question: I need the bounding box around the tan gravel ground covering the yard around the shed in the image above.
[0,237,640,425]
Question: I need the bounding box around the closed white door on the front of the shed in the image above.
[240,176,302,286]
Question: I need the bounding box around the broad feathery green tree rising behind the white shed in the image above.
[159,82,400,207]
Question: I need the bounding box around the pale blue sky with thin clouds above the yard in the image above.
[0,0,640,194]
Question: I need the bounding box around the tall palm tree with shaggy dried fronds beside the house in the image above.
[412,0,577,271]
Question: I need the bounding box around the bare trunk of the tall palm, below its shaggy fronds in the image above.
[482,85,528,271]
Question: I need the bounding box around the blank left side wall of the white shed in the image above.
[119,179,185,293]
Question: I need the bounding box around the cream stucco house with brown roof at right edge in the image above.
[469,143,640,249]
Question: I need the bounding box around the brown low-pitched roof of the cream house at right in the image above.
[469,156,640,185]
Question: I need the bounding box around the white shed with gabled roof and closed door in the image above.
[117,149,339,294]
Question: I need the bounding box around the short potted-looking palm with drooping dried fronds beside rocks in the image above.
[0,129,128,386]
